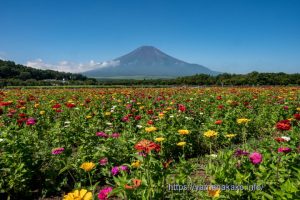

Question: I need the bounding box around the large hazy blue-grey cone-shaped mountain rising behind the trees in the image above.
[82,46,219,78]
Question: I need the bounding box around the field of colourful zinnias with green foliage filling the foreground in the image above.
[0,87,300,200]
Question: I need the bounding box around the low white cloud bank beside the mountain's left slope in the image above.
[25,58,120,73]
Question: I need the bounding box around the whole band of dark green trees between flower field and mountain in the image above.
[0,60,300,87]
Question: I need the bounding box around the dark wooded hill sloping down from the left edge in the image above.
[0,60,97,86]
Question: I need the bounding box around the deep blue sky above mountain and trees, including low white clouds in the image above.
[0,0,300,73]
